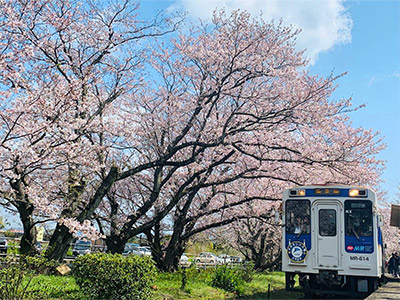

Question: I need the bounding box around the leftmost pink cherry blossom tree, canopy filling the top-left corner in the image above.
[0,0,179,259]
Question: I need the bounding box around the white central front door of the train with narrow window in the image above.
[313,201,341,269]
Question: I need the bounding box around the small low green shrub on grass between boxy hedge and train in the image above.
[211,265,244,295]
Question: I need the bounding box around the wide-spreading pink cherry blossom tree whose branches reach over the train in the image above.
[93,12,383,269]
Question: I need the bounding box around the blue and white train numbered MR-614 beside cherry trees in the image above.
[282,185,384,298]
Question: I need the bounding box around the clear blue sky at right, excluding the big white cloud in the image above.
[311,1,400,202]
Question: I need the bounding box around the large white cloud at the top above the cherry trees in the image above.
[173,0,353,63]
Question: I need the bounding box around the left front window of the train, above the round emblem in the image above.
[285,200,311,235]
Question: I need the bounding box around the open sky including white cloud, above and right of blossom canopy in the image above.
[141,0,400,202]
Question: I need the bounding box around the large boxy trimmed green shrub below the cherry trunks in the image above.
[73,253,156,300]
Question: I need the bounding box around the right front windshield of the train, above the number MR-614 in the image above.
[344,200,373,238]
